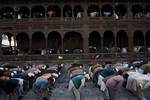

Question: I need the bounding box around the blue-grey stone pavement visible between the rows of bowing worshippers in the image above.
[0,64,150,100]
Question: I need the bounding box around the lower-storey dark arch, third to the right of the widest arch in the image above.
[116,30,128,48]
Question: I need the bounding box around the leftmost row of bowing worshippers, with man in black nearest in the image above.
[0,64,40,100]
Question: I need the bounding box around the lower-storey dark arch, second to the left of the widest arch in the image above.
[32,32,46,54]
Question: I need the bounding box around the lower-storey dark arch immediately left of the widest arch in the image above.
[47,31,61,54]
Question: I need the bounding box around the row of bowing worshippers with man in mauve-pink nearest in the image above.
[89,64,128,100]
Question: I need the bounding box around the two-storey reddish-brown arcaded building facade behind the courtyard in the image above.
[0,0,150,55]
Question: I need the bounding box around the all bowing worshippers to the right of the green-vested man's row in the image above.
[89,60,150,100]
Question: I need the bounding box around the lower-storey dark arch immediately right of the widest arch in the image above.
[89,31,101,53]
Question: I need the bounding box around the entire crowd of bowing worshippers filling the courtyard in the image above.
[0,60,150,100]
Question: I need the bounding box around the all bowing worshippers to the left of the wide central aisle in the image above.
[0,64,61,100]
